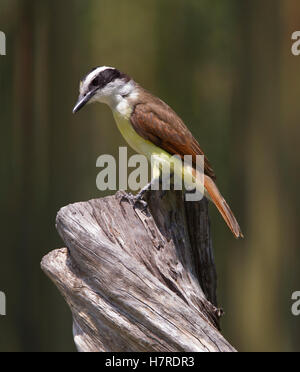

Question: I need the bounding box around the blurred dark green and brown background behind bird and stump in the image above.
[0,0,300,351]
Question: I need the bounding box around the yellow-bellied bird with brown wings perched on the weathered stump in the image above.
[73,66,243,238]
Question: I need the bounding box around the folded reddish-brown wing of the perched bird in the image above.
[131,90,216,180]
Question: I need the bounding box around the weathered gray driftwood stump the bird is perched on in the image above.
[42,191,235,352]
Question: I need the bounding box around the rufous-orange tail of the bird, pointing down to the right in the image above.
[204,175,244,239]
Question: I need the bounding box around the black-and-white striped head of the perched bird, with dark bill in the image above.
[73,66,134,114]
